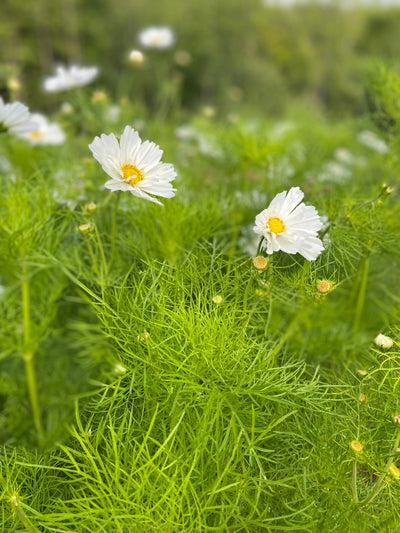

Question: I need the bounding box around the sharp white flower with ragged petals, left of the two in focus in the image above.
[89,126,176,205]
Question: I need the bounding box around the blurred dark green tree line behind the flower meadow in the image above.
[0,0,400,115]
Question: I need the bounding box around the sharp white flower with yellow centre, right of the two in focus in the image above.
[253,187,324,261]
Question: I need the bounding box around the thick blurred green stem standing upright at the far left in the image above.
[22,271,43,440]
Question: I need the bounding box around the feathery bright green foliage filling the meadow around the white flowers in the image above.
[0,97,400,533]
